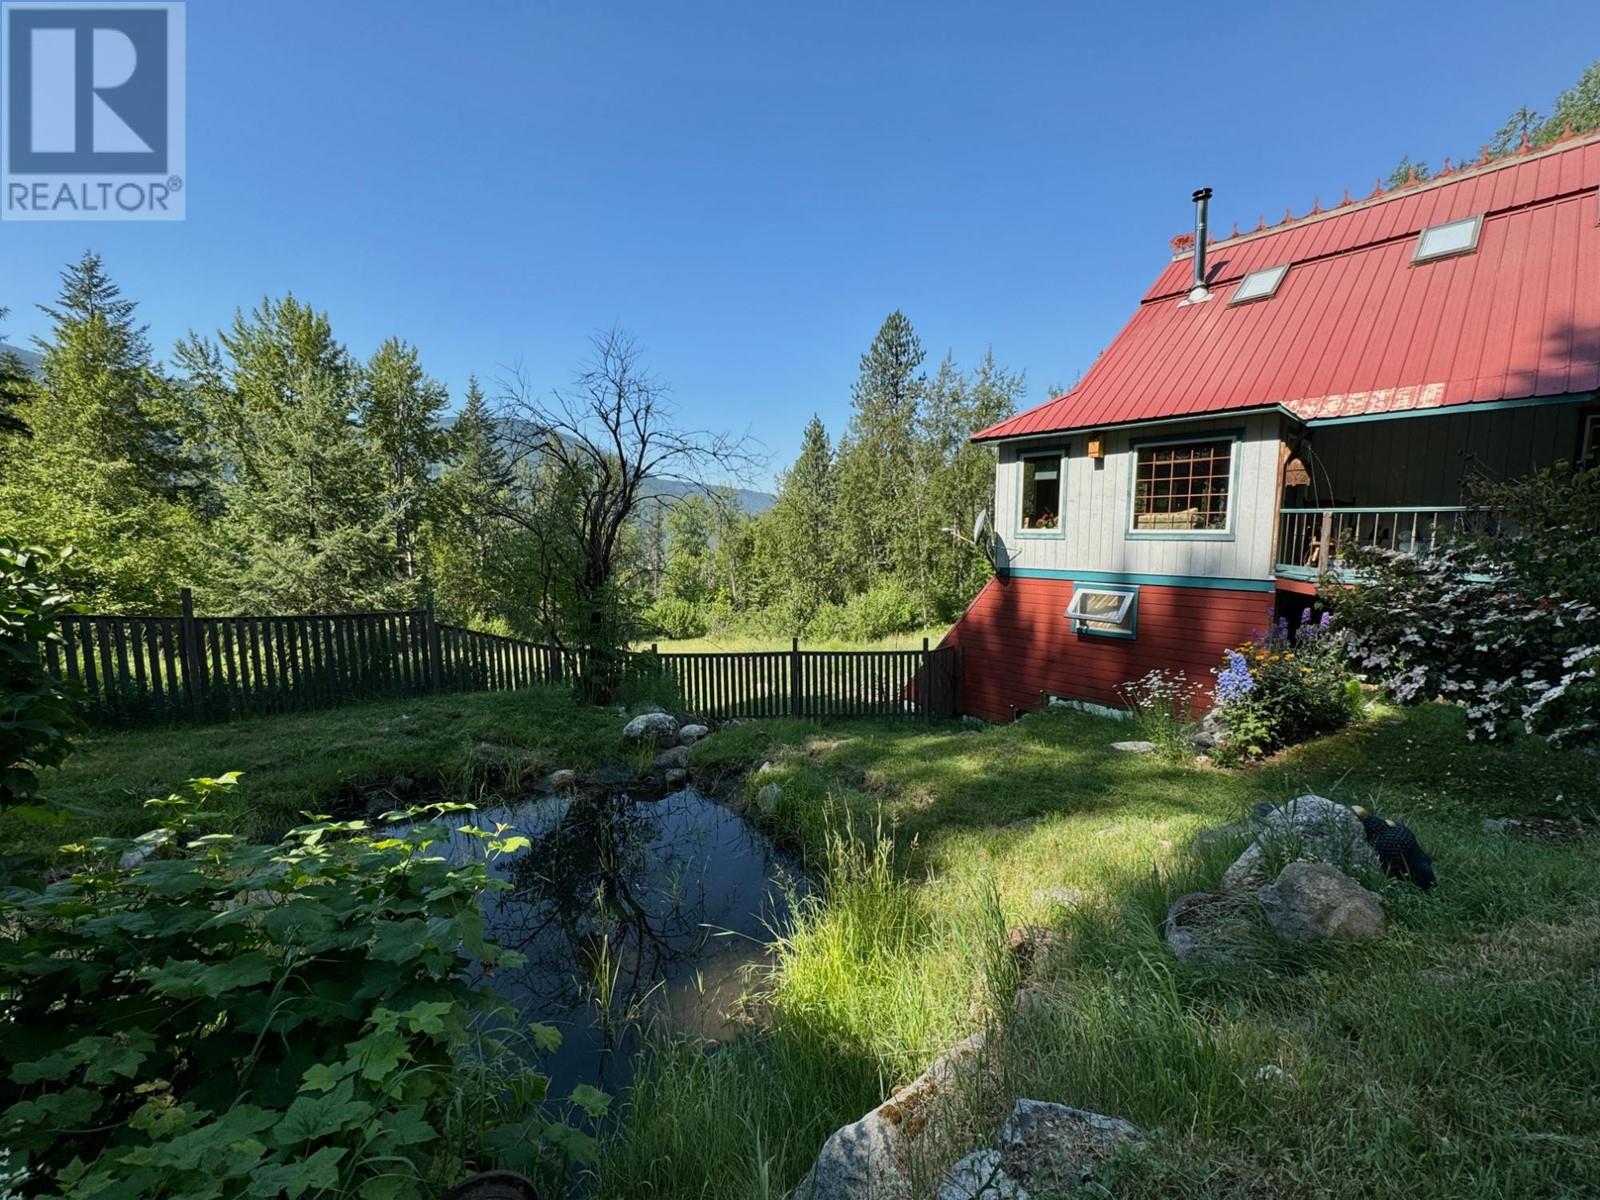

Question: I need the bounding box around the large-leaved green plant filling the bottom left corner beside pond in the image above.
[0,776,606,1200]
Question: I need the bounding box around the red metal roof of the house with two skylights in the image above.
[973,134,1600,442]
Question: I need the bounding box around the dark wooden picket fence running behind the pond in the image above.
[45,590,960,723]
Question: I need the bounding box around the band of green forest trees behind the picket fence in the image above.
[0,253,1026,645]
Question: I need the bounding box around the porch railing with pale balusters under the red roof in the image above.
[1277,504,1486,579]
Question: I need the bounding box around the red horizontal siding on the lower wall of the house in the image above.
[944,579,1274,722]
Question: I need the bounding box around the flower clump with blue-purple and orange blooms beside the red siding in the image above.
[1214,608,1362,758]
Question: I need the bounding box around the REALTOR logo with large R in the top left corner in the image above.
[0,0,186,221]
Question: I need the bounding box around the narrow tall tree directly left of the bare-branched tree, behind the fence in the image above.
[357,338,444,582]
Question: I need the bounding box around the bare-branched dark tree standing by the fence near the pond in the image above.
[496,326,760,694]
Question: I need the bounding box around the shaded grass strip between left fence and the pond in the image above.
[10,688,643,853]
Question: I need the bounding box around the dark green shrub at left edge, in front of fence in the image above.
[0,539,82,808]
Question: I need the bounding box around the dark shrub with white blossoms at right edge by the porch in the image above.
[1334,467,1600,746]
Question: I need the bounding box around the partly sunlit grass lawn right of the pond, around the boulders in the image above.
[602,707,1600,1200]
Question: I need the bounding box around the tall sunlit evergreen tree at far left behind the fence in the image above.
[0,253,200,613]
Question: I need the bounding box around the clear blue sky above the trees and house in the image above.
[0,0,1600,482]
